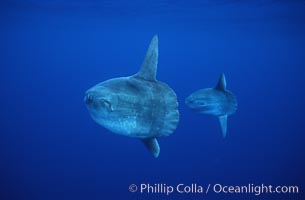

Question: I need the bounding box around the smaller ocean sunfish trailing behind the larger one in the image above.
[185,74,237,138]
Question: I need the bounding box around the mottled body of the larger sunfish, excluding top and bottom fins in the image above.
[85,77,178,139]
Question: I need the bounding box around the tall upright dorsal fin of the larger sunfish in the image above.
[134,35,158,81]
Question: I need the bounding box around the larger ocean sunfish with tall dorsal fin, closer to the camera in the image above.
[85,35,179,157]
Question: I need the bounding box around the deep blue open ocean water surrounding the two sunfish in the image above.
[0,0,305,200]
